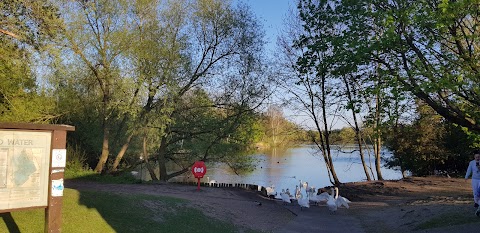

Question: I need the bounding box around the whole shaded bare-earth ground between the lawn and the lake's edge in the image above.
[66,177,480,232]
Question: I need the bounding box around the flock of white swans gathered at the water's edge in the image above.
[265,180,351,213]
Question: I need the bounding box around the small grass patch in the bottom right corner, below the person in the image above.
[415,212,478,230]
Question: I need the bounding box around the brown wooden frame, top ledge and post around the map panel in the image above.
[0,123,75,233]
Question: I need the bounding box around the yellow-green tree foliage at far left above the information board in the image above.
[0,0,61,122]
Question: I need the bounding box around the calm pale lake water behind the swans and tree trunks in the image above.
[198,145,402,191]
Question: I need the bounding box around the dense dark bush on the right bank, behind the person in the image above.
[386,101,473,176]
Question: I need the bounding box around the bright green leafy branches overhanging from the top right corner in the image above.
[358,0,480,132]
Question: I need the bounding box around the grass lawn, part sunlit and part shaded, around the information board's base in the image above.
[0,189,246,233]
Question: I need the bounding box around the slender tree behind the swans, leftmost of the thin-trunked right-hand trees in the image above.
[277,1,340,184]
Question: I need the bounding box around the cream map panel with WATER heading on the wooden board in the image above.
[0,130,52,210]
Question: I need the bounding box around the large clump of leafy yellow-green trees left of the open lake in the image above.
[52,0,266,179]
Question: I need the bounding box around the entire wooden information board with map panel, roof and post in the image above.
[0,123,75,232]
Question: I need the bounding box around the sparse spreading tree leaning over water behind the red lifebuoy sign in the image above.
[133,0,266,180]
